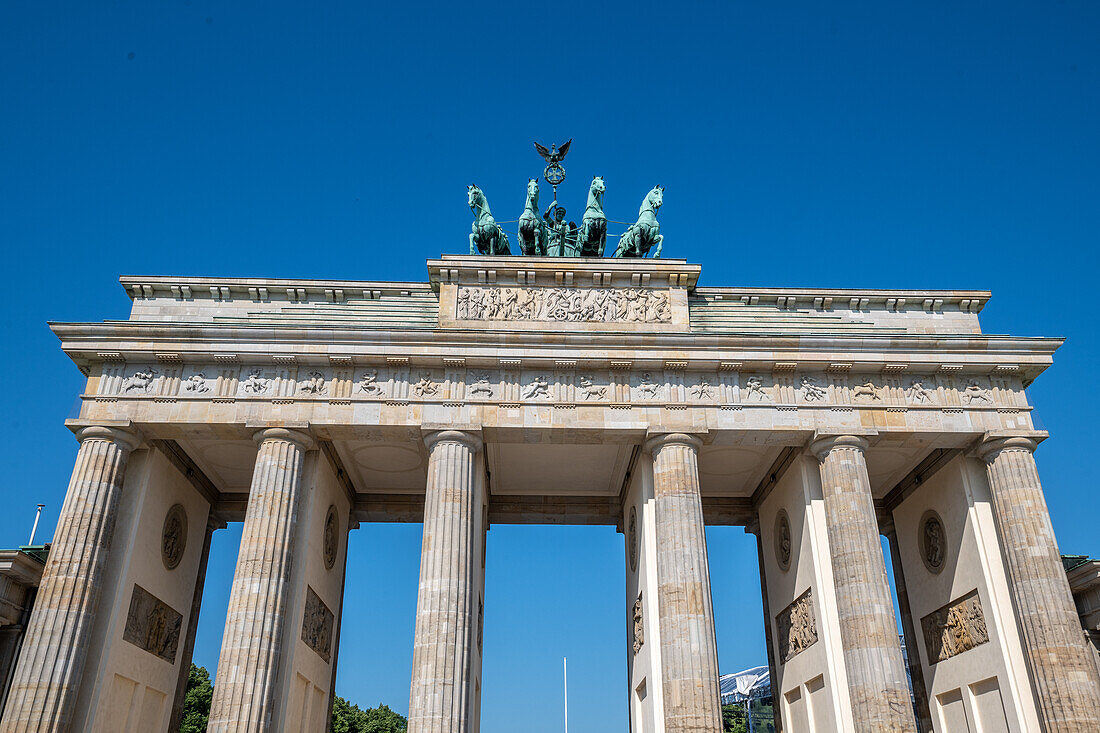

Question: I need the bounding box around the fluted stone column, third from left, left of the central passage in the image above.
[408,430,484,733]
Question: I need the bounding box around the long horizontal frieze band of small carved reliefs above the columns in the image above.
[96,358,1026,409]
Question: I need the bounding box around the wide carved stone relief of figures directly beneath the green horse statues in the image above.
[455,286,672,324]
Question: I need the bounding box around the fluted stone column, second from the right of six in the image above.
[811,435,916,733]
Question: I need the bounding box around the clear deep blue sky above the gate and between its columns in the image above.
[0,0,1100,733]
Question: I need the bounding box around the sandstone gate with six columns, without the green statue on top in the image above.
[0,249,1100,733]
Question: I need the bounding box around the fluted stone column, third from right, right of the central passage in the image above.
[646,433,722,733]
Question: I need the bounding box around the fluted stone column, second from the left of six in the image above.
[208,428,314,733]
